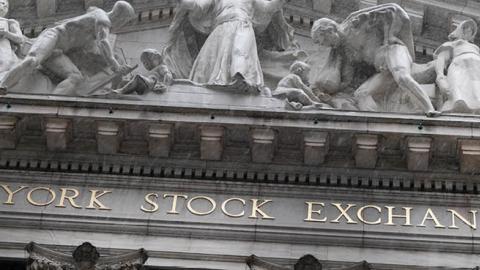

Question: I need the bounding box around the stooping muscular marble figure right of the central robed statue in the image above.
[312,4,439,116]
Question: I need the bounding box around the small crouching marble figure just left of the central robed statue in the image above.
[113,49,173,95]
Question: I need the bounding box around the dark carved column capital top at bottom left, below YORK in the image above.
[25,242,148,270]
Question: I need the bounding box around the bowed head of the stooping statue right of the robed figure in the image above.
[311,18,341,48]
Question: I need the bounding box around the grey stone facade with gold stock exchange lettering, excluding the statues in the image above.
[0,0,480,270]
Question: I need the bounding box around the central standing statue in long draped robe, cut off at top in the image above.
[164,0,296,92]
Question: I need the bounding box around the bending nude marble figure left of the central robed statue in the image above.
[0,1,135,95]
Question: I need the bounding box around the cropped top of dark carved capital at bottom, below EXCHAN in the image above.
[246,254,371,270]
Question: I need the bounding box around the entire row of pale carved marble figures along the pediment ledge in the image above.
[0,0,480,116]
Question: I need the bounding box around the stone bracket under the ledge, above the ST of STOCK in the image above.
[148,124,174,157]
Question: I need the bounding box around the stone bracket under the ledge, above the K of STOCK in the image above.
[250,128,276,163]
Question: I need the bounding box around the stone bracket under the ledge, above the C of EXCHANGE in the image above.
[353,134,378,169]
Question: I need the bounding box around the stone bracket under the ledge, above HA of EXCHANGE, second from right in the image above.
[406,137,432,171]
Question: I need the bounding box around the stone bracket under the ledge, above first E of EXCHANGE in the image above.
[303,131,329,166]
